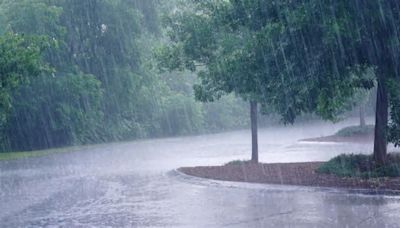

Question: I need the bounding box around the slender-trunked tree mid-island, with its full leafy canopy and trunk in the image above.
[158,1,360,161]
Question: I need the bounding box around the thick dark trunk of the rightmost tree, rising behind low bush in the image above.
[374,80,389,165]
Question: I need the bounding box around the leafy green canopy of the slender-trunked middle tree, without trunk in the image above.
[157,0,370,122]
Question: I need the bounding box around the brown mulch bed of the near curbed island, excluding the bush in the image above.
[178,162,400,191]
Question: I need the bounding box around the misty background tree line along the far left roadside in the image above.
[0,0,256,151]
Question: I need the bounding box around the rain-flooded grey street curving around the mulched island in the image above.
[0,122,400,227]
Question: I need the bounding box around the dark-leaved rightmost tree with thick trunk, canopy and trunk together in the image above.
[241,0,400,165]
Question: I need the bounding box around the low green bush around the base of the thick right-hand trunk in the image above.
[316,154,400,178]
